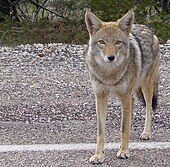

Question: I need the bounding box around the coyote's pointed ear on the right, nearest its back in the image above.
[118,10,134,35]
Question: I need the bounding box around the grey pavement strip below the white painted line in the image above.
[0,149,170,167]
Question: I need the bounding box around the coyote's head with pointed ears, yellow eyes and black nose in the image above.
[85,11,134,65]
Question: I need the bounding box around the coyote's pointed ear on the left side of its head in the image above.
[85,11,102,36]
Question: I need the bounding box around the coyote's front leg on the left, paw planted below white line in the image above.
[90,92,108,163]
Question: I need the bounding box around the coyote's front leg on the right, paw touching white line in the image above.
[117,93,133,158]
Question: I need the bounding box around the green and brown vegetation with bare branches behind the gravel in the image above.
[0,0,170,46]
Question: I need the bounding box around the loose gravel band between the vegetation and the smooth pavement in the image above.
[0,44,170,128]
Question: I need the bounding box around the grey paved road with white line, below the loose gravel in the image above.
[0,120,170,167]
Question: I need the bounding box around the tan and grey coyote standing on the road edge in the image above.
[85,10,159,163]
